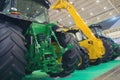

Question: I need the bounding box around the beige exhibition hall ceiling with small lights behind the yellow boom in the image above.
[49,0,120,26]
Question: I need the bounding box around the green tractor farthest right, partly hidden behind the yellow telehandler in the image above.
[90,24,120,62]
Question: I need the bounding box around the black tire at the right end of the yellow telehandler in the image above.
[100,37,113,62]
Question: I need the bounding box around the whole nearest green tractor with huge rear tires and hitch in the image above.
[0,0,82,80]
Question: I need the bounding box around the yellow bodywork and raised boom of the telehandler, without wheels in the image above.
[52,0,105,60]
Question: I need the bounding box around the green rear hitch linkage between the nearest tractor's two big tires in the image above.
[26,23,69,73]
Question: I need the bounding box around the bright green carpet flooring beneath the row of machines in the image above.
[23,60,120,80]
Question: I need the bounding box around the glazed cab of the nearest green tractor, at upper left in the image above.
[0,0,50,23]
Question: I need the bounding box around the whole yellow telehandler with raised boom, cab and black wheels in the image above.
[51,0,112,69]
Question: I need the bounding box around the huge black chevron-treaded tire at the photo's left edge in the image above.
[0,22,26,80]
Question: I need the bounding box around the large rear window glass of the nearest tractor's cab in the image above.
[3,0,49,23]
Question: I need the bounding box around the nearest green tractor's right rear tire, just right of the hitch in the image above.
[49,33,79,77]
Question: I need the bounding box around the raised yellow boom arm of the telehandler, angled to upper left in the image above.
[52,0,96,40]
